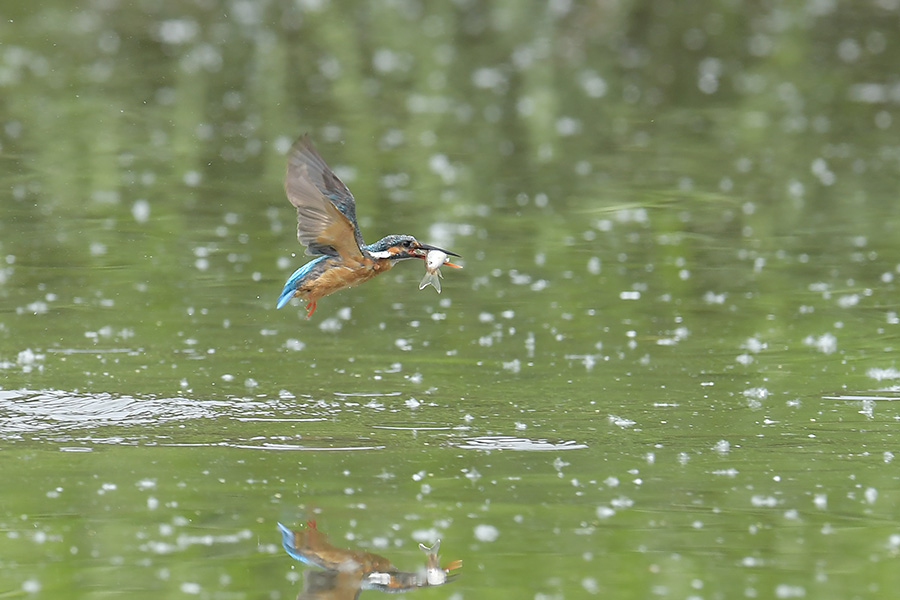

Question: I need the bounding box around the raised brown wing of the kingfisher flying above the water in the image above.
[284,135,363,259]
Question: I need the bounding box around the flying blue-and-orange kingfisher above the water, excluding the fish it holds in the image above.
[276,135,459,319]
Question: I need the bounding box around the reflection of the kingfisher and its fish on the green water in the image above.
[278,521,462,600]
